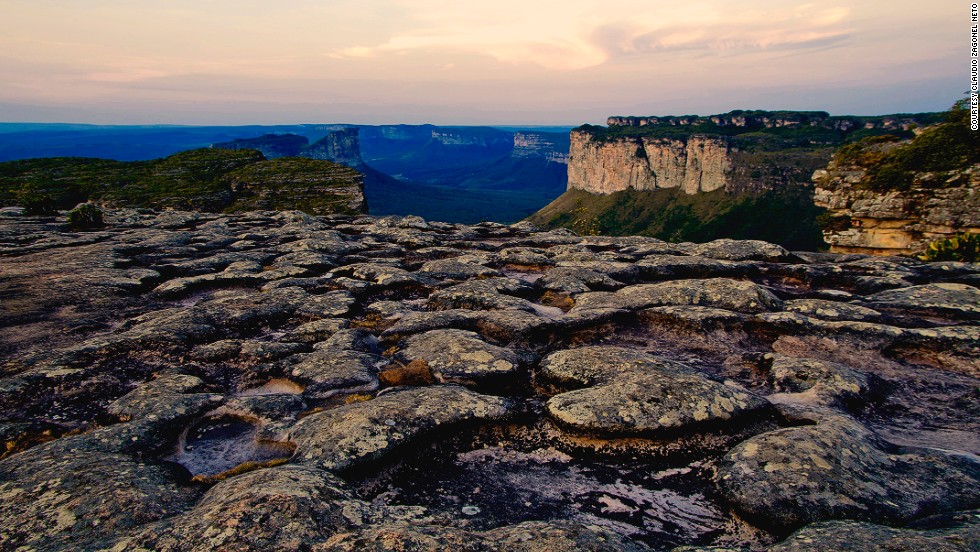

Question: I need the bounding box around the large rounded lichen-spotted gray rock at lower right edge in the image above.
[716,418,980,528]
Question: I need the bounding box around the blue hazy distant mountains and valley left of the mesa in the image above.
[0,123,571,223]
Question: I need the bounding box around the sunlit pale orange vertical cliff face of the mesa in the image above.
[568,130,731,194]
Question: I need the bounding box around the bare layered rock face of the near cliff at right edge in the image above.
[813,165,980,255]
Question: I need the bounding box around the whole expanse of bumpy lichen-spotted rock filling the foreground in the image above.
[0,209,980,551]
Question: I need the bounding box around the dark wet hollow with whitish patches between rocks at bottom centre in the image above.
[362,446,731,548]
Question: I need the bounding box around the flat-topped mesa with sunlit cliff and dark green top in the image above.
[568,110,939,194]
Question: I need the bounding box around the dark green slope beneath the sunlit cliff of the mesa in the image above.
[528,188,824,250]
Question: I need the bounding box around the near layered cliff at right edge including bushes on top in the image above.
[813,102,980,255]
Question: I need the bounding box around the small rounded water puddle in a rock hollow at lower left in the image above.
[166,416,292,476]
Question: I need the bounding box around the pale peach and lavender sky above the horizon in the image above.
[0,0,970,125]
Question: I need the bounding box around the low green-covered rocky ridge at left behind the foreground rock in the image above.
[0,148,363,214]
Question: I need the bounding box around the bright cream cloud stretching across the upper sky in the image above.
[325,0,851,71]
